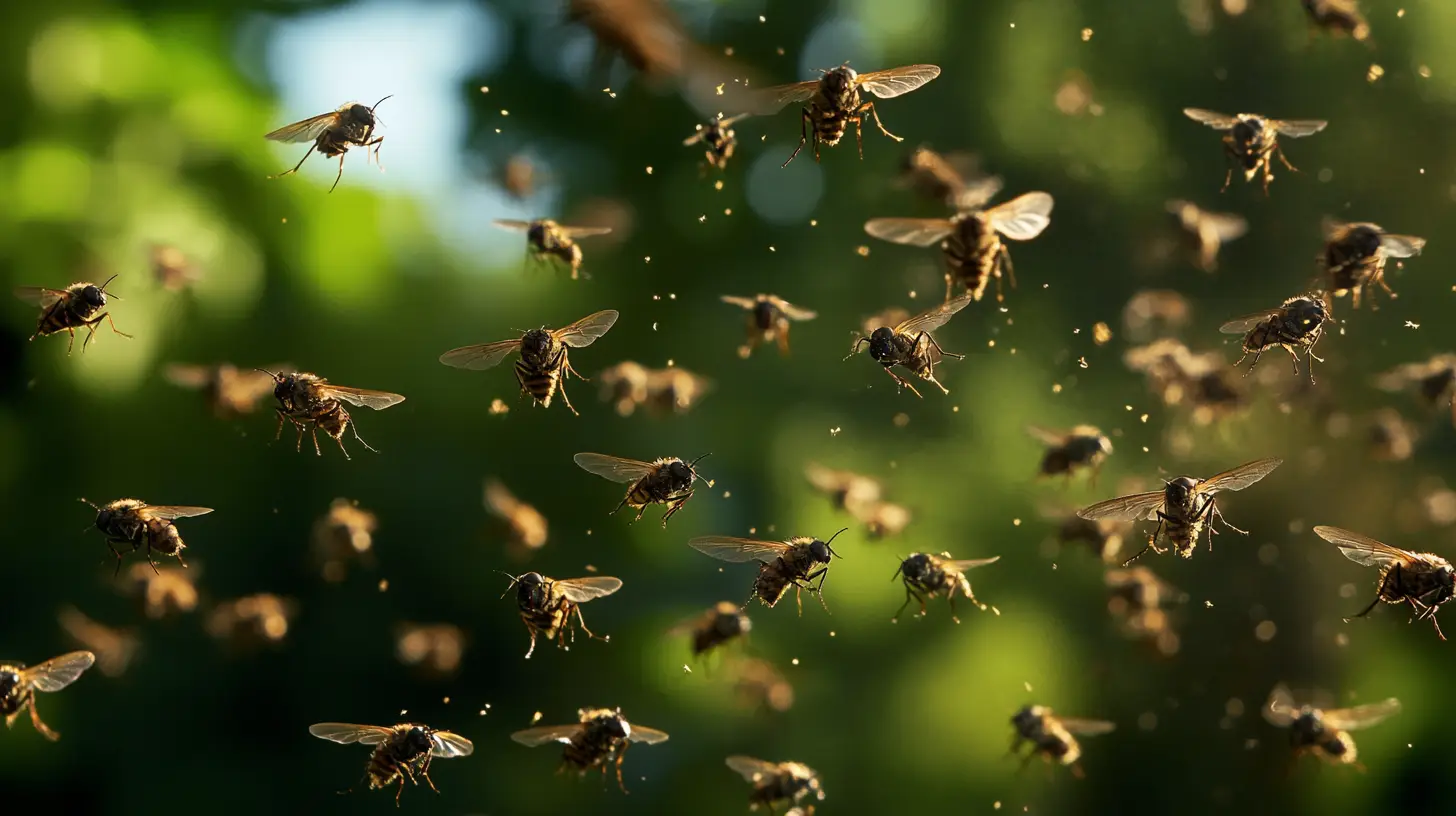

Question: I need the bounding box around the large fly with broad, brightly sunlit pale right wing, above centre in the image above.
[865,188,1056,300]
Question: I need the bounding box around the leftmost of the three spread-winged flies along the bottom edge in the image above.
[309,723,475,806]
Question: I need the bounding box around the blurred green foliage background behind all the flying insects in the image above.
[0,0,1456,815]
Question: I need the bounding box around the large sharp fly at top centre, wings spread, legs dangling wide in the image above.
[753,63,941,168]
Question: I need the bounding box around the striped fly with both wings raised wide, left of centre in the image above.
[440,309,617,414]
